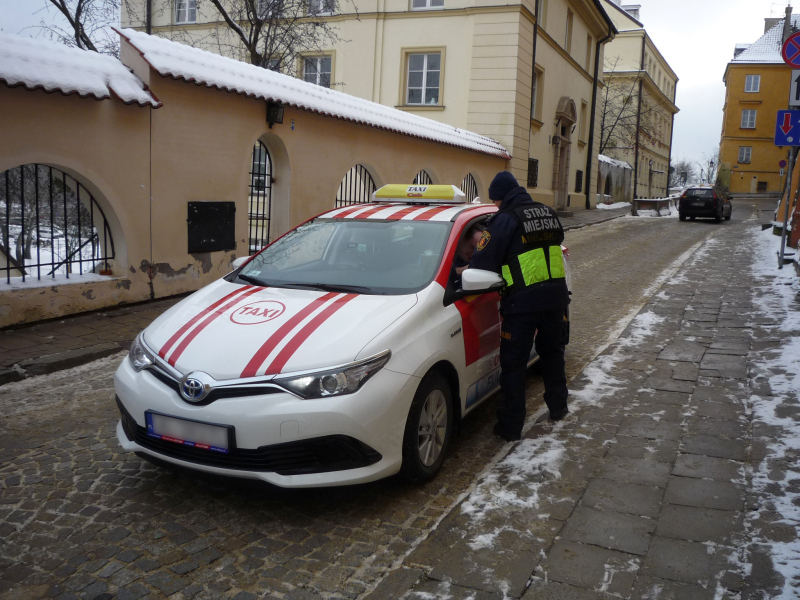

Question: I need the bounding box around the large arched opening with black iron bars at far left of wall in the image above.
[0,164,114,283]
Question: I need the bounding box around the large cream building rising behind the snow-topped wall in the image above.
[123,0,614,208]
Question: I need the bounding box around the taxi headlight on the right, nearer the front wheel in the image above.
[273,350,392,399]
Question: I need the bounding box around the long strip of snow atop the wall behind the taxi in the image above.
[117,29,510,158]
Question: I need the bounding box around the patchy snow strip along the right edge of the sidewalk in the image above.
[751,230,800,600]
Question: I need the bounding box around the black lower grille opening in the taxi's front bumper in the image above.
[117,398,382,475]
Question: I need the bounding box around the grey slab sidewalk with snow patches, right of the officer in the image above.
[367,205,800,600]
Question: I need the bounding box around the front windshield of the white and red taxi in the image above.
[237,219,452,294]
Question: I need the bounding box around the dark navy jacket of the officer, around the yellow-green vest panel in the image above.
[470,186,569,314]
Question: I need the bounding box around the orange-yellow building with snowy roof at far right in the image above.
[719,15,800,194]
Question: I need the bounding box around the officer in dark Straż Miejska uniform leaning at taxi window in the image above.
[470,171,569,441]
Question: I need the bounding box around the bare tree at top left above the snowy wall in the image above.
[38,0,120,56]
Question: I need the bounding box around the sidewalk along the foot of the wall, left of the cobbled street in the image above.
[0,208,630,385]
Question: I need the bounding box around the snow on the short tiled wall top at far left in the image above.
[0,33,161,108]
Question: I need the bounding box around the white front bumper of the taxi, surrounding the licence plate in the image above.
[114,359,419,487]
